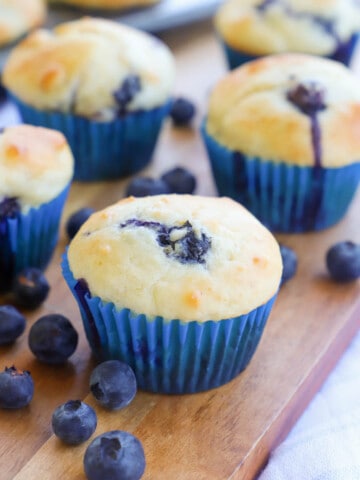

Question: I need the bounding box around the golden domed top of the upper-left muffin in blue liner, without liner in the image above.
[3,17,174,121]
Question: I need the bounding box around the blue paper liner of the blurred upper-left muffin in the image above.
[12,96,171,181]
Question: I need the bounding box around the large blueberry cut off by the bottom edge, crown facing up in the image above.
[84,430,146,480]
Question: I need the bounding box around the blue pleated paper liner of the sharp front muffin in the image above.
[62,253,276,394]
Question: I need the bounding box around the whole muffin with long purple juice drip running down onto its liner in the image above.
[202,54,360,232]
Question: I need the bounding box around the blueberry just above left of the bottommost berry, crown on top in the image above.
[51,400,97,445]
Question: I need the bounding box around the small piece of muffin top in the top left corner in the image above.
[0,0,46,46]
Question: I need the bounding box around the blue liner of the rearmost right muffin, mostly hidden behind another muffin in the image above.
[221,34,359,70]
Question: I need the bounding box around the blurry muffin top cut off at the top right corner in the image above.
[215,0,360,55]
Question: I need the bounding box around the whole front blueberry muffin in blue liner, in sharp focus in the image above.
[63,194,282,393]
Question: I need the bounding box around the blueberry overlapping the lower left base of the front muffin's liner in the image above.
[90,360,137,410]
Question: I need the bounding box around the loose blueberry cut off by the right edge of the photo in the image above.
[326,241,360,282]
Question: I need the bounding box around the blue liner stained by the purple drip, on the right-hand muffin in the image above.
[201,125,360,233]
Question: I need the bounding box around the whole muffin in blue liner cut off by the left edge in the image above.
[0,125,74,291]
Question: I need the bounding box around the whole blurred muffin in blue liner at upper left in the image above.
[3,17,174,180]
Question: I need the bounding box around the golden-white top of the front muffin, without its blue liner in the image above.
[68,194,282,321]
